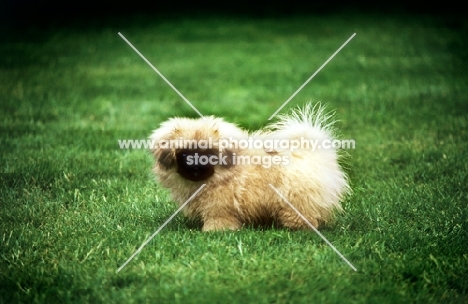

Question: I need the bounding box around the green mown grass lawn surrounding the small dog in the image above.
[0,13,468,303]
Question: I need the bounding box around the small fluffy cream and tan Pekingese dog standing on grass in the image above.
[150,104,349,231]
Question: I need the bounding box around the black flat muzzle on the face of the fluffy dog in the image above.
[176,150,215,182]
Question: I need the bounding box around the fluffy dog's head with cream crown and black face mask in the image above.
[150,116,247,182]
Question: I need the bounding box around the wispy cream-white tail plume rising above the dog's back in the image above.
[263,103,335,145]
